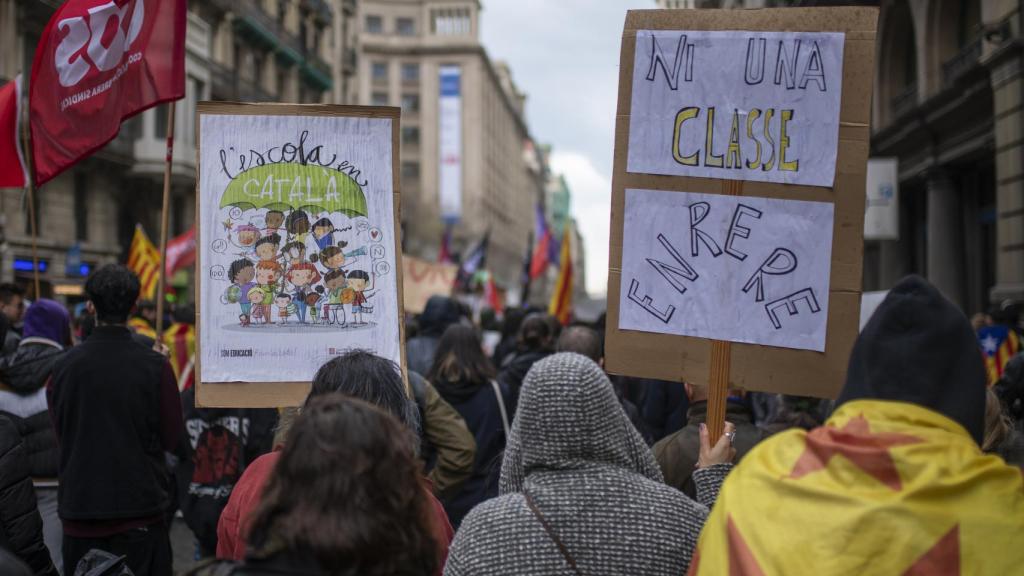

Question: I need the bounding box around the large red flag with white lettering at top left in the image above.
[29,0,186,184]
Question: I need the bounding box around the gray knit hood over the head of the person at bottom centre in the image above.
[500,353,664,494]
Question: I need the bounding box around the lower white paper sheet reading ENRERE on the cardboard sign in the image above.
[618,189,834,352]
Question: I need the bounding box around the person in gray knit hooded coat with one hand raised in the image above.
[444,353,734,576]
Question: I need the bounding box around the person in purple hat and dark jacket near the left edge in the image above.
[0,298,72,569]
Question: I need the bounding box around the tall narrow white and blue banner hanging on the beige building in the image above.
[437,66,462,222]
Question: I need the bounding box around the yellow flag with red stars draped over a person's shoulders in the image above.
[689,400,1024,576]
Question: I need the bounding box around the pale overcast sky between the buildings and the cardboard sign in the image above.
[480,0,654,295]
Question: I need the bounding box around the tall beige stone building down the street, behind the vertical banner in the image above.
[357,0,545,293]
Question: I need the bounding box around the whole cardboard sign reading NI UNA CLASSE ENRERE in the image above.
[605,7,878,397]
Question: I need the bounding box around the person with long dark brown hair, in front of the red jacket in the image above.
[194,393,439,576]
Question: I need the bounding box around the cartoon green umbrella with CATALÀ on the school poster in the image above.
[220,162,367,217]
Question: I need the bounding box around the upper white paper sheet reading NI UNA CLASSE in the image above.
[627,30,845,187]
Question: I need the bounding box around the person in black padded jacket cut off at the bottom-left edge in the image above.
[0,416,57,576]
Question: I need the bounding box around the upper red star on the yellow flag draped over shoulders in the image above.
[790,414,923,490]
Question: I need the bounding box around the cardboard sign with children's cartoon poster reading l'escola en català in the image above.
[196,102,404,407]
